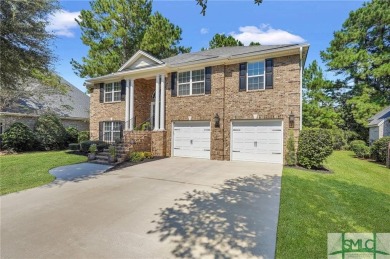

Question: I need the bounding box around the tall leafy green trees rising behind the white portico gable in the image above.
[71,0,188,77]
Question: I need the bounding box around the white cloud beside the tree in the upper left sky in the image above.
[47,10,80,38]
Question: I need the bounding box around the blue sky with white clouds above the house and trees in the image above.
[49,0,363,91]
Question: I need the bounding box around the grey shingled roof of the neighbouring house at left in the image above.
[0,78,89,119]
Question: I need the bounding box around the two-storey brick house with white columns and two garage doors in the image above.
[87,44,309,163]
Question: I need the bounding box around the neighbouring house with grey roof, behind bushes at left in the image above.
[0,79,89,134]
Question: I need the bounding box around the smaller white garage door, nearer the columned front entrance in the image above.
[172,121,211,159]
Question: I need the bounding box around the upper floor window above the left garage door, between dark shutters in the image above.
[178,69,205,96]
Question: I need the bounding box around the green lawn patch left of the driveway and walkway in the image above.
[0,151,87,194]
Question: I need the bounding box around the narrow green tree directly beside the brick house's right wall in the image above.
[302,60,342,129]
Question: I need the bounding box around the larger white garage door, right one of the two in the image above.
[231,120,283,164]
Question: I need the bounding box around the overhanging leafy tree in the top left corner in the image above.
[0,0,60,91]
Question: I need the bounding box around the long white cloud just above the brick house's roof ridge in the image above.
[230,24,305,45]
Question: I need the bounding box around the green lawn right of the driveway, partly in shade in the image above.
[276,151,390,259]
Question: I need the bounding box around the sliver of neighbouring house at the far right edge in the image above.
[368,106,390,145]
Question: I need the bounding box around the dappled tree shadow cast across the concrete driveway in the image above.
[148,175,281,258]
